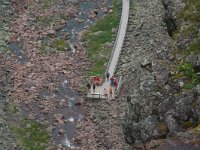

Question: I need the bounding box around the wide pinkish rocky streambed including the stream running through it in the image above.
[1,0,112,149]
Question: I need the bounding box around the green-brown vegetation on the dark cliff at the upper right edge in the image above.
[173,0,200,89]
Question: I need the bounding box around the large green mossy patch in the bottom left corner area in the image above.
[12,119,50,150]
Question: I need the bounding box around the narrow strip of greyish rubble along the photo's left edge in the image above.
[0,0,15,149]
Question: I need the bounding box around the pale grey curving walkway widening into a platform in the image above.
[87,0,130,99]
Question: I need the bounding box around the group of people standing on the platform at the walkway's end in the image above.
[87,72,118,99]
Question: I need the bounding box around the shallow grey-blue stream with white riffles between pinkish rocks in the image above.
[9,0,112,149]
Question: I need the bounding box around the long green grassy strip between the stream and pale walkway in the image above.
[83,0,121,76]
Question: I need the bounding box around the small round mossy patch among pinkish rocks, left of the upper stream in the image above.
[52,39,69,51]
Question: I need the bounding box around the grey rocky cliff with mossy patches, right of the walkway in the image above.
[117,0,200,148]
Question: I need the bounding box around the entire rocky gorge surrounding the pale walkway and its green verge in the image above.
[0,0,200,150]
